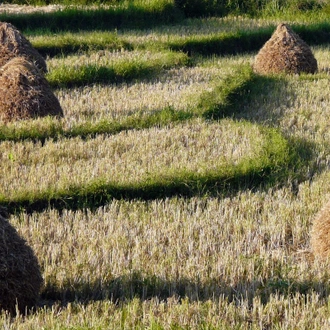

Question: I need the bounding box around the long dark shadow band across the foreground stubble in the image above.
[41,271,330,306]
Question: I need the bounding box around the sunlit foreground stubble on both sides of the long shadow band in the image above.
[4,171,330,329]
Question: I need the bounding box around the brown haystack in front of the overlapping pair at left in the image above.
[0,57,63,123]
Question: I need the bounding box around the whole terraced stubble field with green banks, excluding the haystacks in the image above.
[0,0,330,329]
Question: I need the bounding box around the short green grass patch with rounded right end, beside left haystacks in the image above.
[46,51,189,88]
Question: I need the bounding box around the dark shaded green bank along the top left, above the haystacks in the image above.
[0,3,183,33]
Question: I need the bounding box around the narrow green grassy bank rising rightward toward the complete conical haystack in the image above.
[0,65,256,142]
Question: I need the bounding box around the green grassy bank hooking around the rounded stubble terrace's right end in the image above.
[0,122,298,213]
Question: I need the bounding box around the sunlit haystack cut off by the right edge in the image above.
[310,202,330,259]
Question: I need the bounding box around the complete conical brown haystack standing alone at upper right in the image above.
[253,24,317,74]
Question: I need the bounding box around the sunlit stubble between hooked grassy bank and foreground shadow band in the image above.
[12,187,312,298]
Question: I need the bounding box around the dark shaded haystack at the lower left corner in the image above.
[0,216,43,313]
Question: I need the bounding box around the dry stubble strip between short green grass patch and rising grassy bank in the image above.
[56,64,240,127]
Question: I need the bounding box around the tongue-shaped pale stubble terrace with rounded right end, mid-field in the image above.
[0,121,263,197]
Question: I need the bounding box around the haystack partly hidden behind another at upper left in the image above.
[0,22,47,72]
